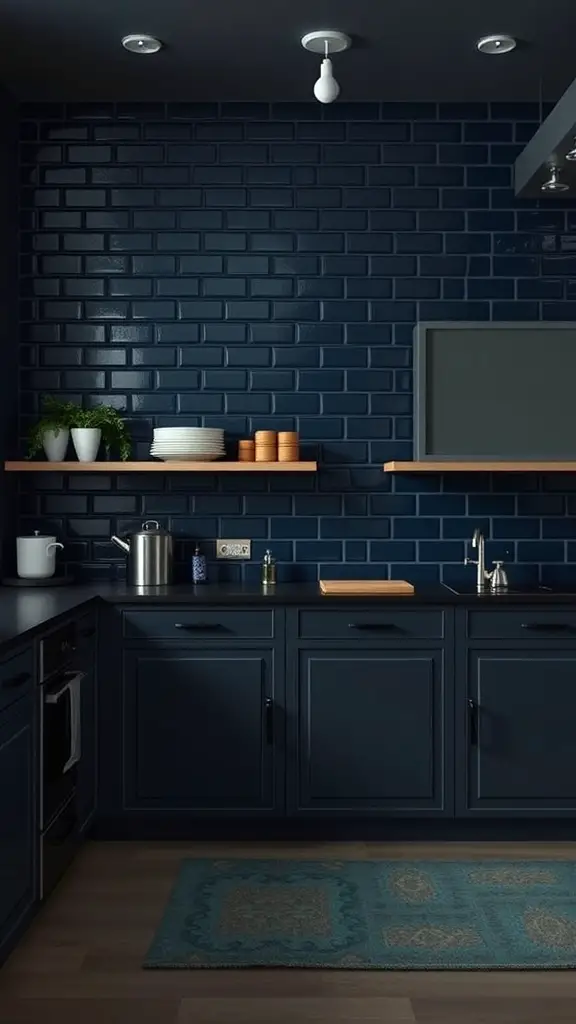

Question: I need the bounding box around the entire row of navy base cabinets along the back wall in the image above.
[98,600,576,835]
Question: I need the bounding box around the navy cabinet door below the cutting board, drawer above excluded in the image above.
[290,649,452,816]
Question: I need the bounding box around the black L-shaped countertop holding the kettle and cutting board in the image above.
[0,583,576,648]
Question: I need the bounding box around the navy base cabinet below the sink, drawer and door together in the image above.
[456,606,576,817]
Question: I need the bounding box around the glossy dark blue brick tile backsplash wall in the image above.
[13,102,576,583]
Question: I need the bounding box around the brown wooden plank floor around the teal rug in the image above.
[0,843,576,1024]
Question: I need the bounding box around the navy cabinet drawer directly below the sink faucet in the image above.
[466,606,576,642]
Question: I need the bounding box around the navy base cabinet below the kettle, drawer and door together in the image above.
[110,605,284,821]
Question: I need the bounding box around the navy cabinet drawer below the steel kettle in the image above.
[122,606,274,643]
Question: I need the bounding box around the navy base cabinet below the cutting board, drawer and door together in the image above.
[287,602,454,817]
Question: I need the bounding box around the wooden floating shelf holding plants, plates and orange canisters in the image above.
[4,460,318,473]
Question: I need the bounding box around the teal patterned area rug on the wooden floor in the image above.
[143,859,576,971]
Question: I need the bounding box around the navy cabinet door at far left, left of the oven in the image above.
[0,698,36,958]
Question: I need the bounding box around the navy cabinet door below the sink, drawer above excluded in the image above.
[457,647,576,817]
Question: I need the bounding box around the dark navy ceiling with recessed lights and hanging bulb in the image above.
[0,0,576,101]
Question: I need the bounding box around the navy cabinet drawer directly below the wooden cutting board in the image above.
[298,598,444,641]
